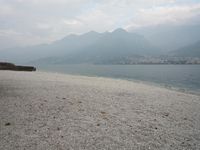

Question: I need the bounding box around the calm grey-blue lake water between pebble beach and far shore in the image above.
[39,65,200,93]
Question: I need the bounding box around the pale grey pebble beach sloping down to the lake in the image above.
[0,71,200,150]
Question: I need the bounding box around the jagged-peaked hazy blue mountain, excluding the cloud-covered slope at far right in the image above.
[1,29,159,63]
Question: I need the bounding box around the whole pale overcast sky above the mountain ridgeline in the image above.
[0,0,200,49]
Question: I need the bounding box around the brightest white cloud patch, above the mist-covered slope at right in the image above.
[126,4,200,29]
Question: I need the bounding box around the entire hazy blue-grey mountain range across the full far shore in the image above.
[0,25,200,64]
